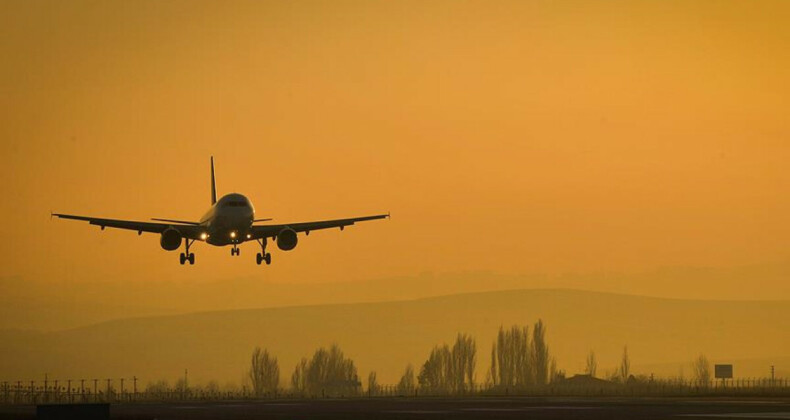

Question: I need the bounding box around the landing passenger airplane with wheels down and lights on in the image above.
[51,156,390,265]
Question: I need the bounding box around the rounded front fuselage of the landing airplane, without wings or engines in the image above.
[200,193,255,246]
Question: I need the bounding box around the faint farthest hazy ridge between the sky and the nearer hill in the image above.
[0,263,790,331]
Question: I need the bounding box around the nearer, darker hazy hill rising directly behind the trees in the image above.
[0,290,790,383]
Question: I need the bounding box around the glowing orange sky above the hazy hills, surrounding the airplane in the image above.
[0,1,790,299]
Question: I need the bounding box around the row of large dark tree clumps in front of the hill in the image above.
[247,320,557,396]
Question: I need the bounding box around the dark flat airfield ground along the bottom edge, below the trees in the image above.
[0,397,790,420]
